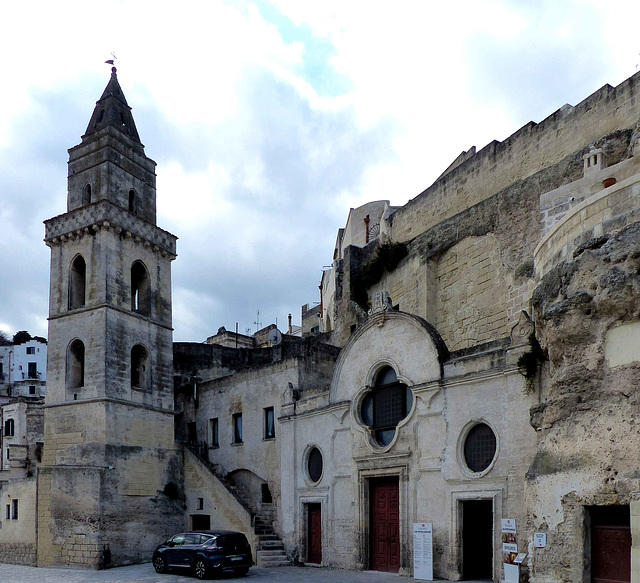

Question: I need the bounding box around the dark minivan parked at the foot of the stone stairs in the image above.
[153,530,253,579]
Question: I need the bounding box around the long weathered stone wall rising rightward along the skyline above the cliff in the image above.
[389,73,640,241]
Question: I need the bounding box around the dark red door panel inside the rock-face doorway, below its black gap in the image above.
[591,525,631,583]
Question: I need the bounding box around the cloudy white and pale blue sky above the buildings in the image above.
[0,0,640,342]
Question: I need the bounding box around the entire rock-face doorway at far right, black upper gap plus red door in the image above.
[588,506,631,583]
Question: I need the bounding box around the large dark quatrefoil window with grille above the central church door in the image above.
[360,366,413,447]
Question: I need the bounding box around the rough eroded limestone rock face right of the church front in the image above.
[527,222,640,581]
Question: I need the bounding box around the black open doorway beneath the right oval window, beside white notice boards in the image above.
[462,500,493,579]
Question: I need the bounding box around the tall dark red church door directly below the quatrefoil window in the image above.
[369,476,400,573]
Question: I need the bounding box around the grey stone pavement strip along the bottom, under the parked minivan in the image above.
[0,563,488,583]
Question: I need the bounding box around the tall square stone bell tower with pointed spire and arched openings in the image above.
[38,67,183,568]
